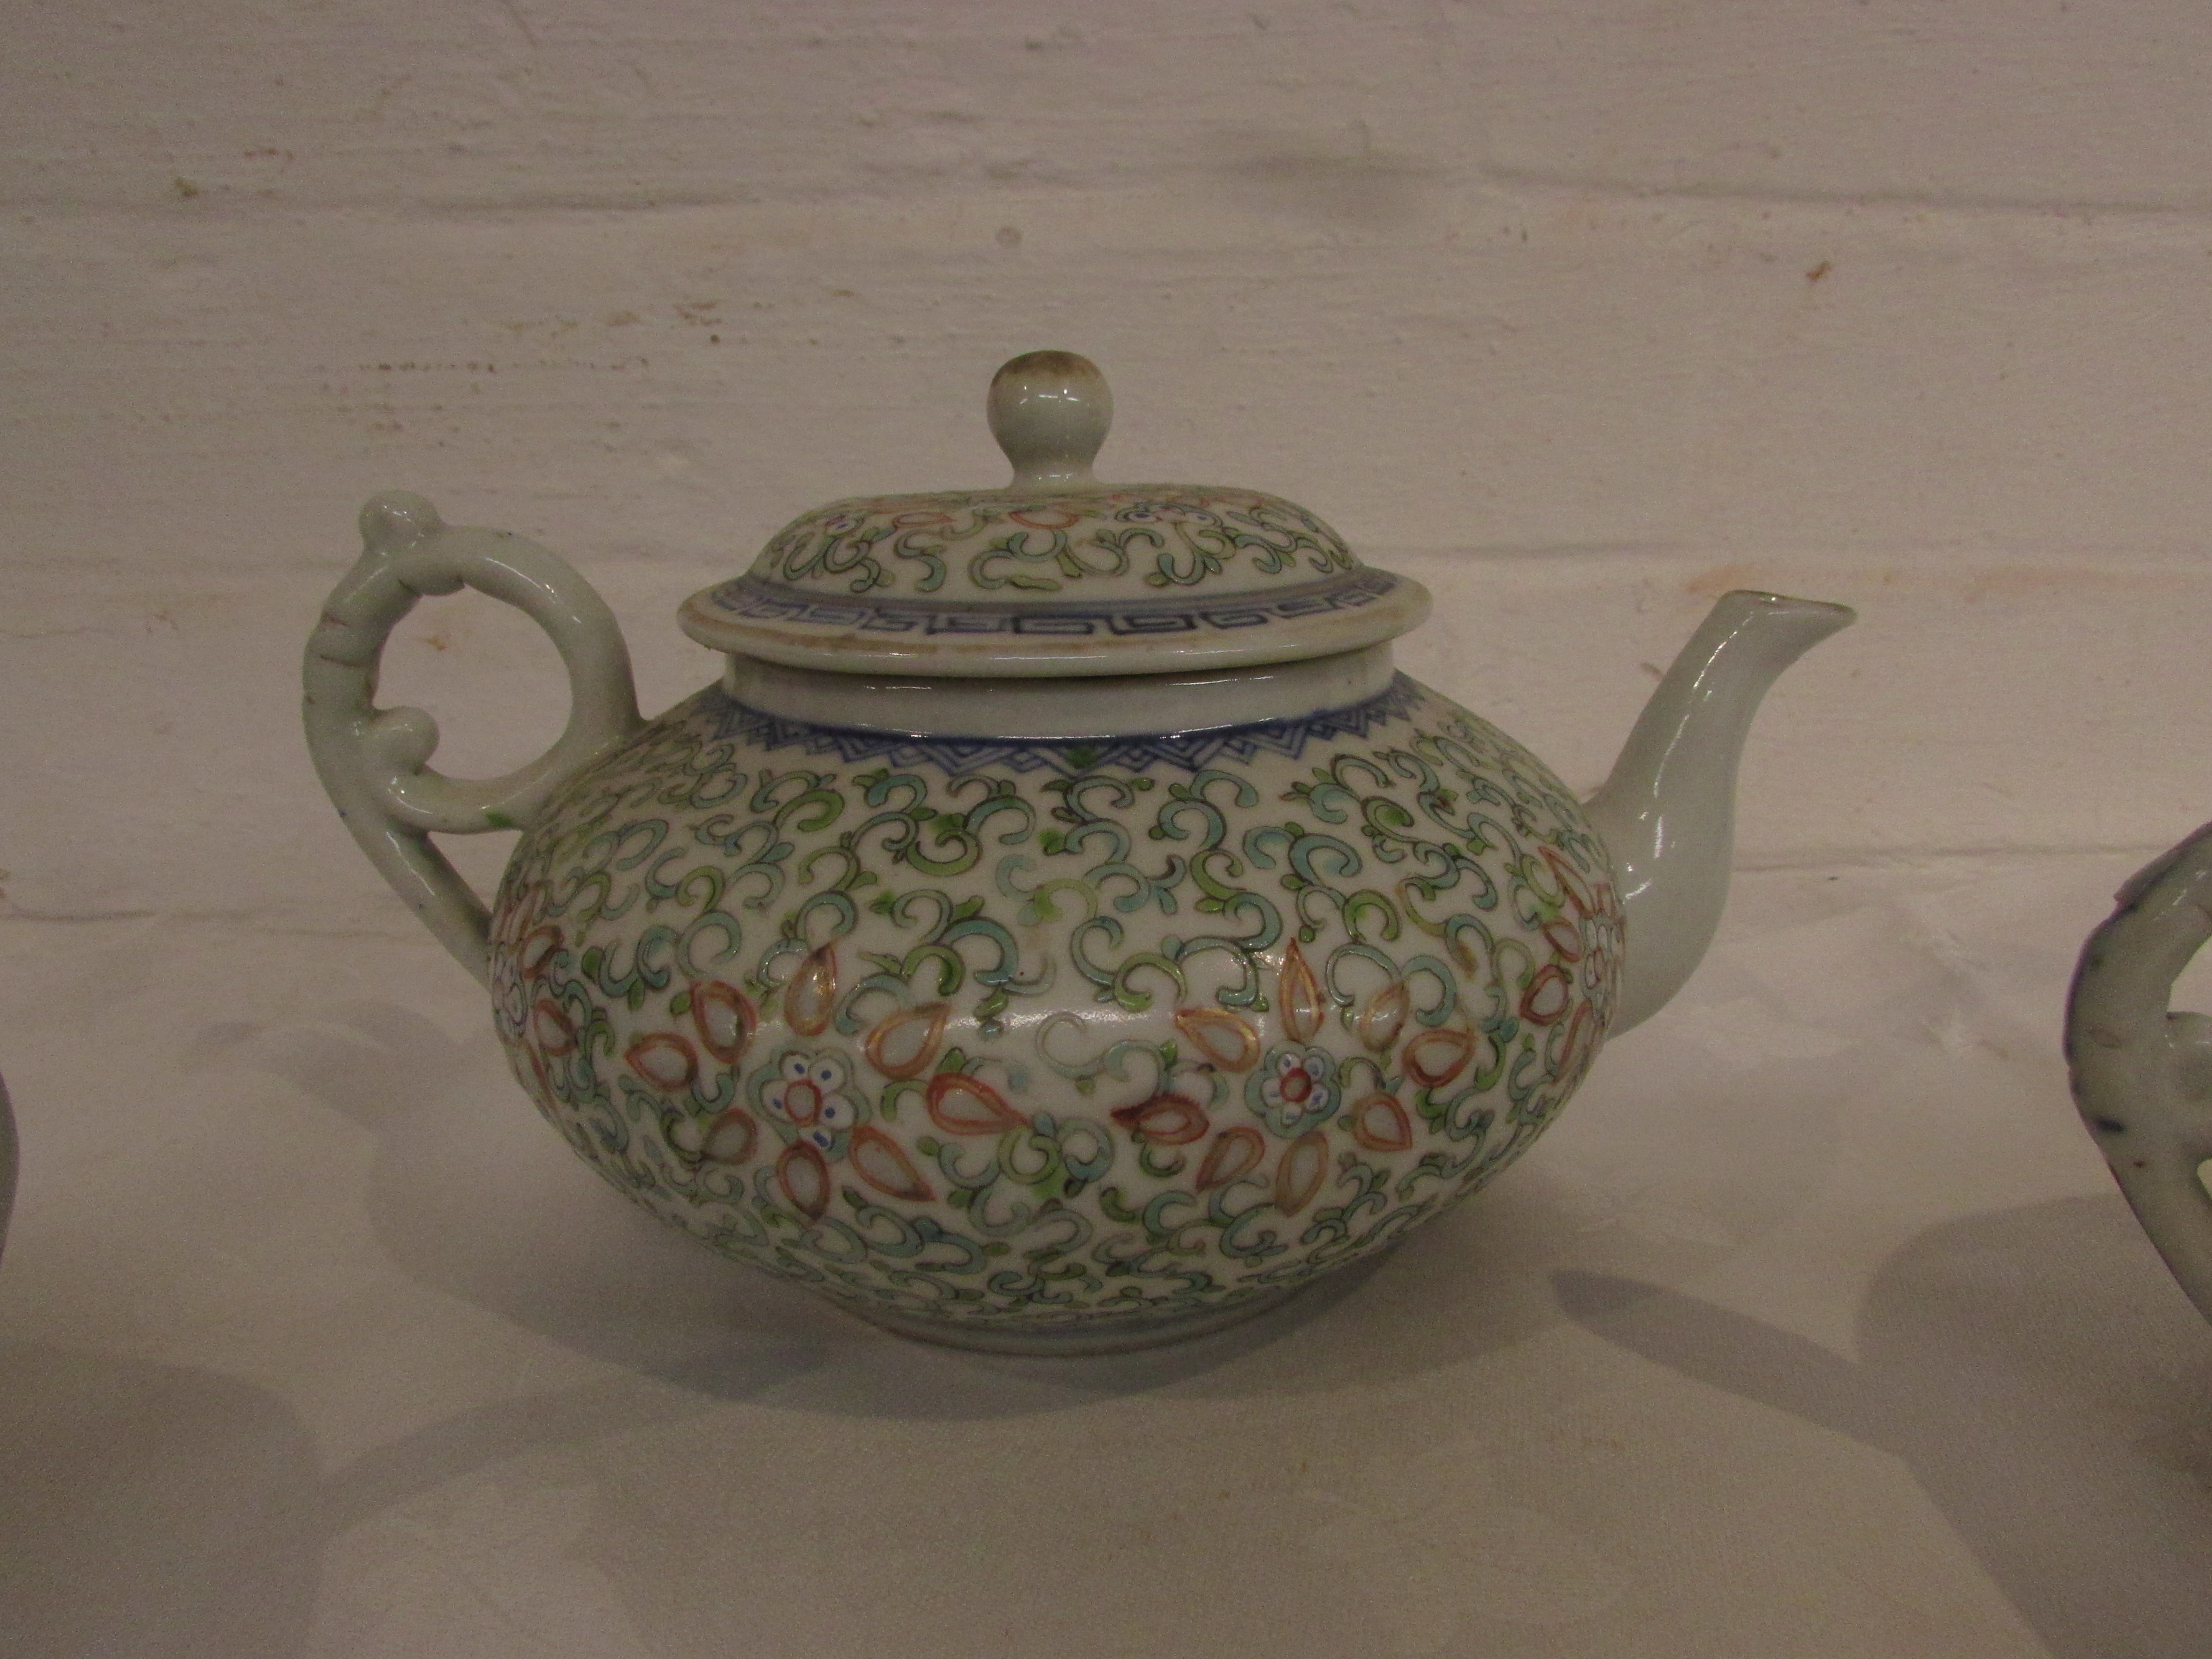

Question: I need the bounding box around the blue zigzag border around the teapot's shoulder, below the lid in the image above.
[714,675,1427,777]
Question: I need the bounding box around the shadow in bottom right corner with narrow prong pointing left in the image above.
[1553,1197,2212,1659]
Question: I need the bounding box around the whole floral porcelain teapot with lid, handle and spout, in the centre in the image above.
[305,352,1851,1354]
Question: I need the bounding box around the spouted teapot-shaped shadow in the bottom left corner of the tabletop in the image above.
[0,1345,769,1659]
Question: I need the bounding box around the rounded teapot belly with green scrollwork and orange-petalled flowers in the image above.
[491,677,1622,1351]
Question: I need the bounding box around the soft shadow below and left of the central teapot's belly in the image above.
[254,1004,1469,1420]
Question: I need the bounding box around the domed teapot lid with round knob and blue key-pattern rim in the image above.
[679,352,1429,679]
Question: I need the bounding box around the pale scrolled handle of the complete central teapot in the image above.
[305,491,642,980]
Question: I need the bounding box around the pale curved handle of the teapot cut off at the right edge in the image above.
[2066,823,2212,1318]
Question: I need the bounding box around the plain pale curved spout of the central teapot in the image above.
[1589,590,1858,1036]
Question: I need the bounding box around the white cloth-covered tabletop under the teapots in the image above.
[0,856,2212,1659]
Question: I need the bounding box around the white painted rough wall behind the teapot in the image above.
[0,0,2212,929]
